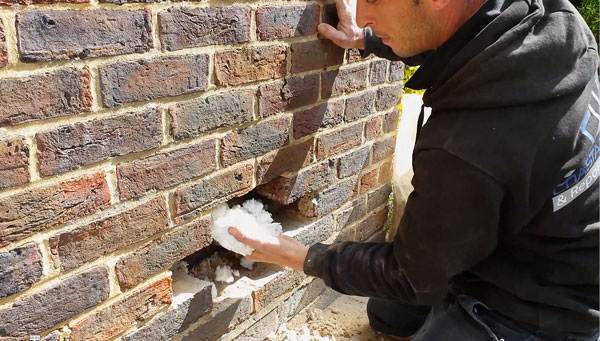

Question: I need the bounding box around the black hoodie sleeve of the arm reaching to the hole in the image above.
[304,150,504,305]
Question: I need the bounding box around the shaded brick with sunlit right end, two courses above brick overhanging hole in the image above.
[294,100,344,139]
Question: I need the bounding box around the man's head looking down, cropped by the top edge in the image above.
[356,0,486,57]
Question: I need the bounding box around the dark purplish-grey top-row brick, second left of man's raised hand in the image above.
[158,6,251,51]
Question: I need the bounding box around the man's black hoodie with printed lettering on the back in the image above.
[304,0,600,332]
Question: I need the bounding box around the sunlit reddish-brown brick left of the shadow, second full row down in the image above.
[215,45,287,86]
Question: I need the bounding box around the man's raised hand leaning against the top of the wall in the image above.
[318,0,365,49]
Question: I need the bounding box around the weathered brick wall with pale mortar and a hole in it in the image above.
[0,0,403,340]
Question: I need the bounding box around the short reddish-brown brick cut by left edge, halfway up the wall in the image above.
[0,137,29,188]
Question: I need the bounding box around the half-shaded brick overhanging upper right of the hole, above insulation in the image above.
[257,162,335,205]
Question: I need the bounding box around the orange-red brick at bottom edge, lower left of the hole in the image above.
[69,278,171,341]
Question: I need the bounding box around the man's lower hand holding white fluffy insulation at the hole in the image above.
[229,227,308,271]
